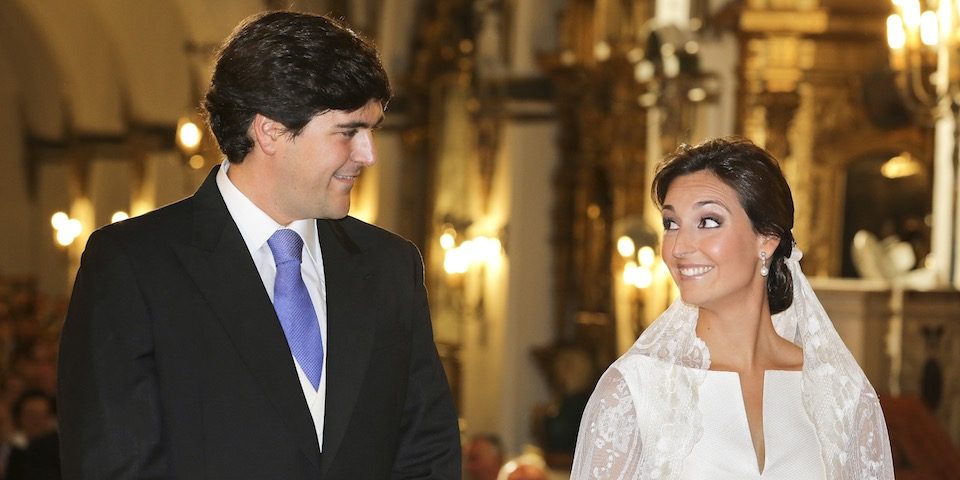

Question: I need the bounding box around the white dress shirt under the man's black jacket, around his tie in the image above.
[217,160,327,452]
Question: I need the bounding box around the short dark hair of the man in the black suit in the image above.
[203,12,391,163]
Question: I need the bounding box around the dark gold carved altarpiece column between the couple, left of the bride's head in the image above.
[542,1,649,372]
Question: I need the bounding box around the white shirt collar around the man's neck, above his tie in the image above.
[217,160,321,263]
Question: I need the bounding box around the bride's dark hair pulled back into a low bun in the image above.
[651,137,794,313]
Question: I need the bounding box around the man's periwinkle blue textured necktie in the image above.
[267,228,323,390]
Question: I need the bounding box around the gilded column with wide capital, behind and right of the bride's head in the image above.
[738,0,932,276]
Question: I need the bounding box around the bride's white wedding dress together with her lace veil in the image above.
[570,249,893,480]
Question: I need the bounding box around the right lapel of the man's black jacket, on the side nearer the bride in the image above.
[317,220,375,472]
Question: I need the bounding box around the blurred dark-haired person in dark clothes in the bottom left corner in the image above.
[5,390,60,480]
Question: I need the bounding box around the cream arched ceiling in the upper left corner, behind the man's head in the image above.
[0,0,327,141]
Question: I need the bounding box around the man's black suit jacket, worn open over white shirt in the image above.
[59,168,460,480]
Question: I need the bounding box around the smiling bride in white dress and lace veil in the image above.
[571,138,893,480]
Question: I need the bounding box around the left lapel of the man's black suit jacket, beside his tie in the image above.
[175,168,319,468]
